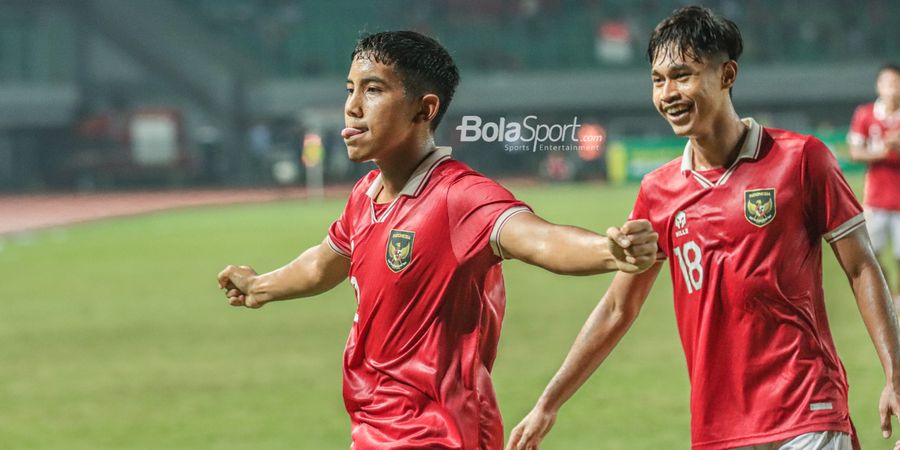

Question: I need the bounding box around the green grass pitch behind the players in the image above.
[0,179,890,450]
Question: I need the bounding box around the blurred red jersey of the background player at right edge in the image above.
[847,101,900,211]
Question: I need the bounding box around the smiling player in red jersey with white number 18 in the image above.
[508,6,900,450]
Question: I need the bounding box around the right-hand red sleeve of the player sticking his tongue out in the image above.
[447,175,531,260]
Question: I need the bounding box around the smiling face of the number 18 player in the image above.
[650,45,737,136]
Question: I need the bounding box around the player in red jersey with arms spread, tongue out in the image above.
[218,32,657,450]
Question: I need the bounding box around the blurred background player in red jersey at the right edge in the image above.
[847,64,900,305]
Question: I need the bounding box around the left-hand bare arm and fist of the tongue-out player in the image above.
[218,240,350,308]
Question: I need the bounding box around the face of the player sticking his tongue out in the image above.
[341,56,427,162]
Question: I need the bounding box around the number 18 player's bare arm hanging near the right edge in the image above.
[831,227,900,449]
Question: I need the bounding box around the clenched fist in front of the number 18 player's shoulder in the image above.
[606,219,659,273]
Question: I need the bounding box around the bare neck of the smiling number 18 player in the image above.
[691,112,749,170]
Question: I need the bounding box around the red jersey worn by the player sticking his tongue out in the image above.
[328,148,529,450]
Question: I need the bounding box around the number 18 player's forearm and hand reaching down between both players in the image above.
[506,263,662,450]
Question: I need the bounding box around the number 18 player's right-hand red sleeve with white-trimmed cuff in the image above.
[803,138,865,244]
